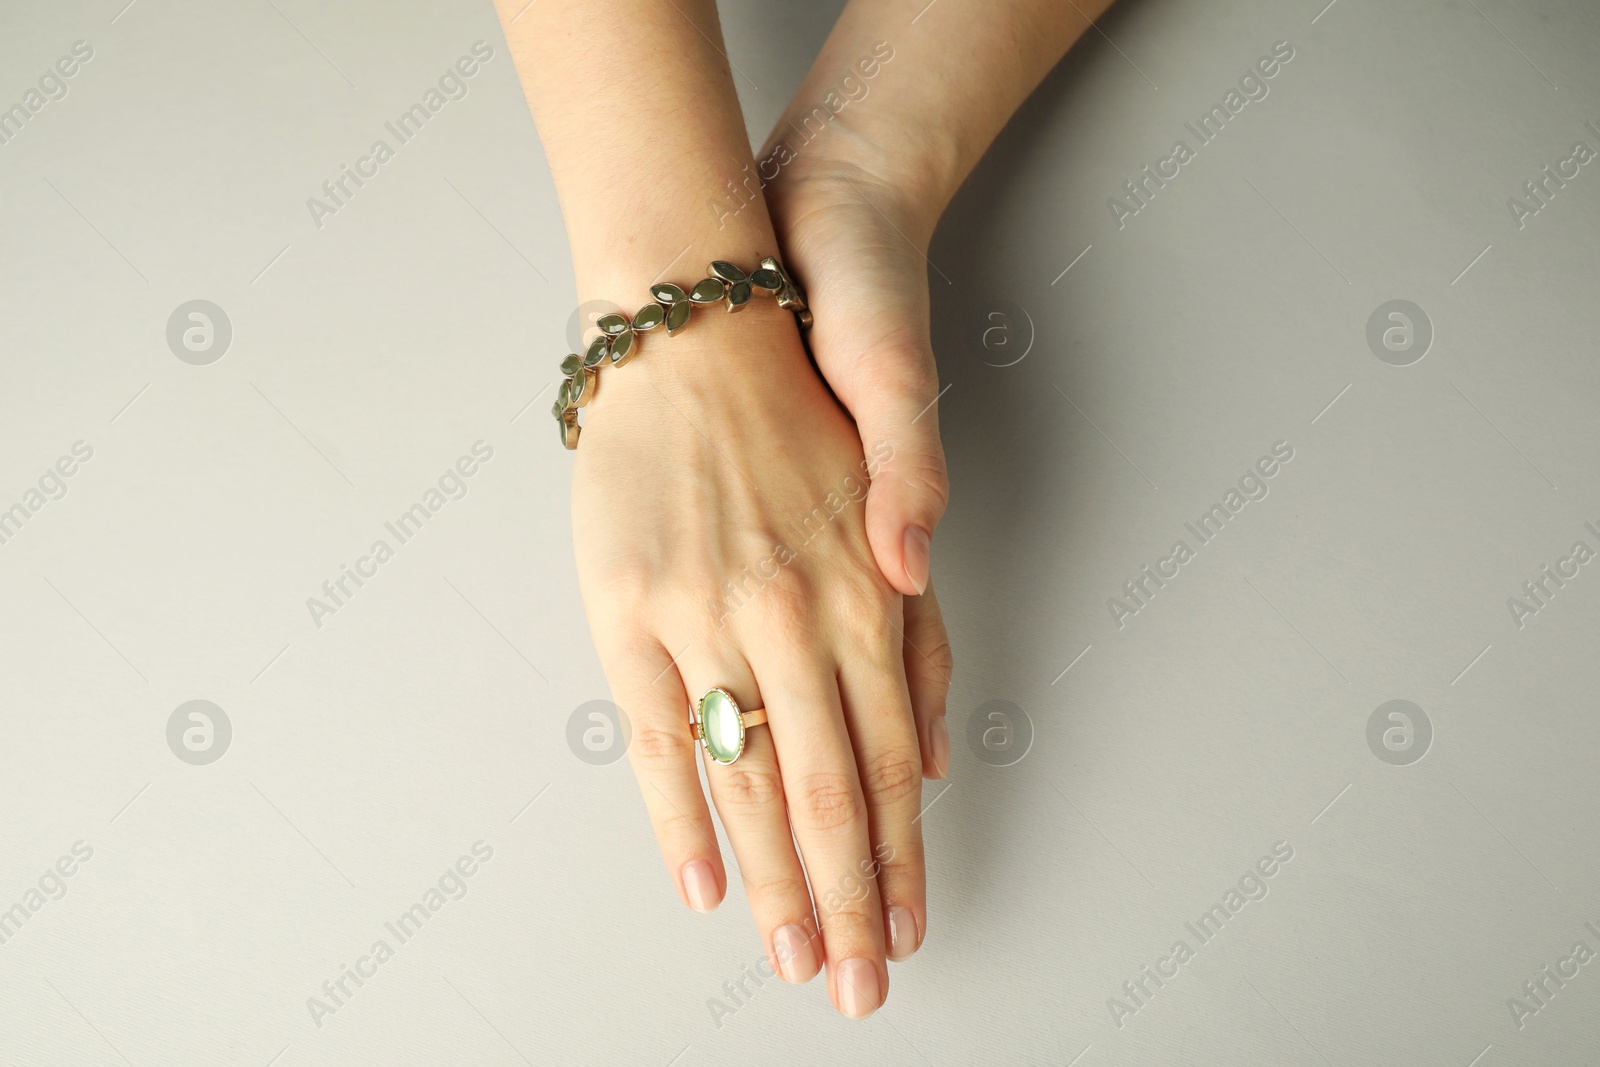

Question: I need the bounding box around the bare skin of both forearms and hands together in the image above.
[496,0,1104,1017]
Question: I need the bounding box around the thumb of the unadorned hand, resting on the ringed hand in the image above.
[846,349,950,597]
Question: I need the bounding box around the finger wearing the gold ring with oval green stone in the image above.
[678,649,822,982]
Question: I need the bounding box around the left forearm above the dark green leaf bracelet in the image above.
[496,0,778,306]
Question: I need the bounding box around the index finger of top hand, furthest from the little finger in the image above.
[838,597,928,960]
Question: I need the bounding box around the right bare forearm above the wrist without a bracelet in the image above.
[762,0,1112,231]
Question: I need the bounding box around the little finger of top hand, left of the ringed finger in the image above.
[595,630,728,912]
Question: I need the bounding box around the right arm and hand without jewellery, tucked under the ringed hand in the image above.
[757,0,1110,710]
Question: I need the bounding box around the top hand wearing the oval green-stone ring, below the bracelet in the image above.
[573,301,928,1017]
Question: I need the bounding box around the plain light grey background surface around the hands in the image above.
[0,0,1600,1067]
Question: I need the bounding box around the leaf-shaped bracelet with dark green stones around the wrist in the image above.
[550,256,811,448]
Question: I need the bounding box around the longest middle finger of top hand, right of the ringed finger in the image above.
[752,633,888,1019]
